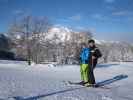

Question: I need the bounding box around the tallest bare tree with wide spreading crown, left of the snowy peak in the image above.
[9,15,51,65]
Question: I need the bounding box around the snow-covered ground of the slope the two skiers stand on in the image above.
[0,61,133,100]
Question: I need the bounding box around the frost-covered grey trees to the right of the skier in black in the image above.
[99,41,133,63]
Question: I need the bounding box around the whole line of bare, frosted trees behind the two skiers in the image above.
[0,15,133,65]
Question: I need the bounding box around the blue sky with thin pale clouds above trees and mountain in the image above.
[0,0,133,42]
